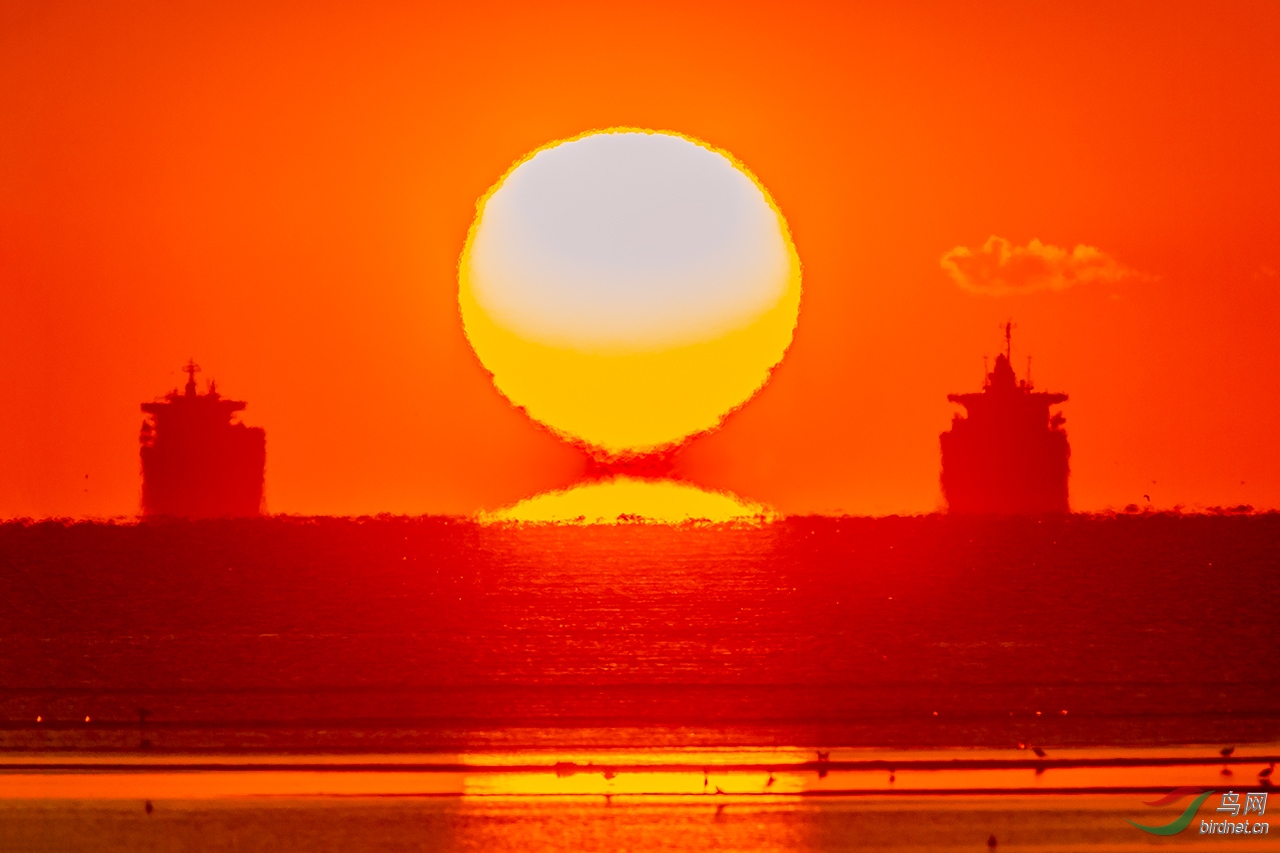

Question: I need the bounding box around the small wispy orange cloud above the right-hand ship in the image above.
[941,236,1151,296]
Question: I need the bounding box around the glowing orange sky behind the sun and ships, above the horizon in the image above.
[0,0,1280,517]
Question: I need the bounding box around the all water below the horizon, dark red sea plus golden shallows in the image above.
[0,514,1280,850]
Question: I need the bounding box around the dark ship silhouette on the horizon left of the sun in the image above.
[141,360,266,519]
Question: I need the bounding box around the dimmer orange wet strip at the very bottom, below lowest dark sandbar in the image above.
[0,794,1280,853]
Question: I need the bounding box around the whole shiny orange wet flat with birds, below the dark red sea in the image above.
[0,745,1280,852]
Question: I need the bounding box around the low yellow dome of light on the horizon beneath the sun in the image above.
[481,476,774,524]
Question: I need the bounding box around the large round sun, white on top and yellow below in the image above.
[458,128,800,450]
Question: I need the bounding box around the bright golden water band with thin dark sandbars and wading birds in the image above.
[0,744,1277,799]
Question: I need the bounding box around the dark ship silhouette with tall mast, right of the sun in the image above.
[940,324,1071,514]
